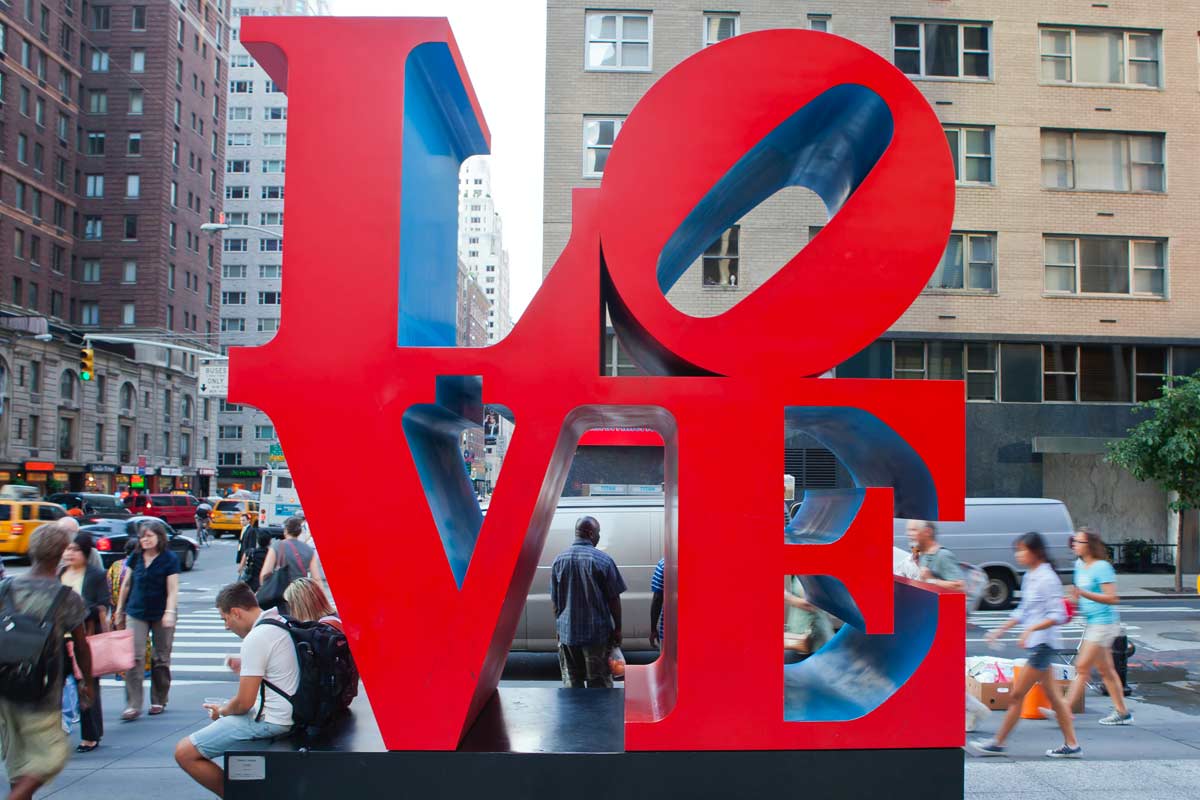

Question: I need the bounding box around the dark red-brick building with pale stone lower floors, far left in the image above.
[0,0,228,491]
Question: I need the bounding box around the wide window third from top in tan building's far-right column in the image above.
[1045,236,1166,297]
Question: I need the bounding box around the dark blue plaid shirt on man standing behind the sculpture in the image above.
[550,539,625,646]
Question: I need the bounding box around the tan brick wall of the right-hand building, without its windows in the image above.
[544,0,1200,341]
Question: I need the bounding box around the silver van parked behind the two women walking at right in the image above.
[893,498,1075,610]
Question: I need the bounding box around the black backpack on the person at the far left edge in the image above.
[0,578,72,703]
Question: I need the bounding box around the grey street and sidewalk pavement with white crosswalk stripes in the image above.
[7,539,1200,800]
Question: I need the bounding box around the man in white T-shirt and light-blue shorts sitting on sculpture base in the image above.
[175,581,300,796]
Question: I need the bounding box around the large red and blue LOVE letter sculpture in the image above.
[229,18,965,796]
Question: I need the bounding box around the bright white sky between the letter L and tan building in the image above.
[330,0,546,319]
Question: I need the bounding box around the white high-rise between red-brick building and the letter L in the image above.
[217,0,329,488]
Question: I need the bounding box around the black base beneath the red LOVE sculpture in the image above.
[226,687,964,800]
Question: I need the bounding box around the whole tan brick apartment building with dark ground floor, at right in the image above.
[544,0,1200,569]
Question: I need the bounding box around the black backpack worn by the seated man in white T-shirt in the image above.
[258,616,359,742]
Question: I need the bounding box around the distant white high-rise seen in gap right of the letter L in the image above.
[458,156,512,344]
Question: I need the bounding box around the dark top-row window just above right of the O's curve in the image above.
[892,20,991,79]
